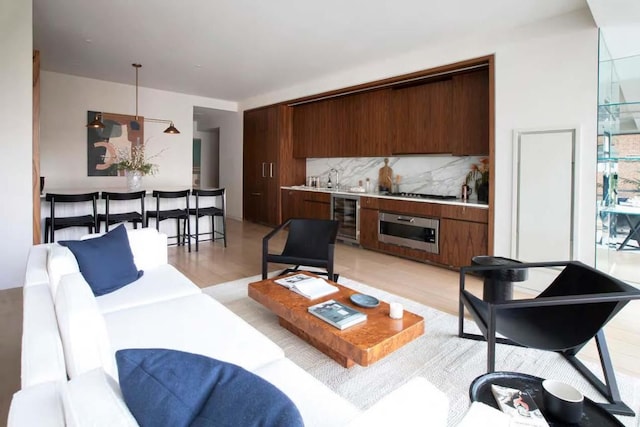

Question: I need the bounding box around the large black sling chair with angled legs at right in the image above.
[458,261,640,415]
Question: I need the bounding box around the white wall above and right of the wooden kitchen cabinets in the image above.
[241,8,598,264]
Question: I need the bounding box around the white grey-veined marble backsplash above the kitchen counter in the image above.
[307,155,483,198]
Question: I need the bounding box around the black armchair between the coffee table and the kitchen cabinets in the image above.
[262,218,338,281]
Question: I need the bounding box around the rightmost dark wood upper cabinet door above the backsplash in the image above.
[450,67,490,156]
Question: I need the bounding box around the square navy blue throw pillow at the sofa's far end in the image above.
[58,224,144,296]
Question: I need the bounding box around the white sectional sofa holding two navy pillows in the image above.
[8,228,448,427]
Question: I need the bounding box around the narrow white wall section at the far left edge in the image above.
[0,0,33,289]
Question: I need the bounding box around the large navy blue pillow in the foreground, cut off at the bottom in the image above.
[116,349,304,427]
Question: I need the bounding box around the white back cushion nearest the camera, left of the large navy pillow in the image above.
[62,369,138,427]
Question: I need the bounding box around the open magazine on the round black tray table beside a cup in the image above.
[491,384,549,427]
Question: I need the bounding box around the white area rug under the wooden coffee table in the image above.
[203,276,640,427]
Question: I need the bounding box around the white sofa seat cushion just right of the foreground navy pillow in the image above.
[254,359,360,427]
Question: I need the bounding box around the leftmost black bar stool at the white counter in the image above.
[44,191,98,243]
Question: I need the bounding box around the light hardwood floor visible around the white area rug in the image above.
[0,220,640,424]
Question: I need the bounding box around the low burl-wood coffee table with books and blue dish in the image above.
[249,279,424,368]
